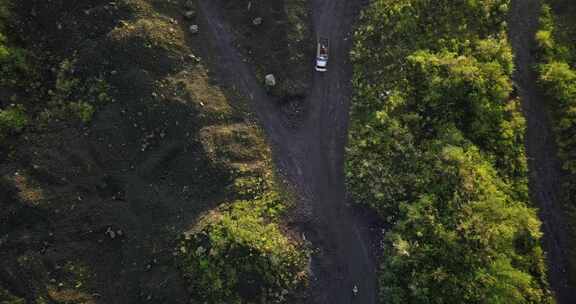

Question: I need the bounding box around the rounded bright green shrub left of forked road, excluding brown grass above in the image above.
[180,192,306,303]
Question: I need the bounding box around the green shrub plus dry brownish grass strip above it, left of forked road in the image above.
[177,125,308,304]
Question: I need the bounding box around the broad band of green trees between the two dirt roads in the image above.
[346,0,552,303]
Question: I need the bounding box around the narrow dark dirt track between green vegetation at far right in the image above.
[509,0,576,304]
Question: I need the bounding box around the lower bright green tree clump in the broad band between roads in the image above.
[381,136,551,304]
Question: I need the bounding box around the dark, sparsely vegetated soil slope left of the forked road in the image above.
[0,0,268,304]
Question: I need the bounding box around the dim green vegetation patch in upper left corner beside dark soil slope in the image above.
[0,0,111,142]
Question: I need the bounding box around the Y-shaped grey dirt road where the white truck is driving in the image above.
[199,0,377,304]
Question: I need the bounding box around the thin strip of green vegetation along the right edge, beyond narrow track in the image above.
[536,0,576,284]
